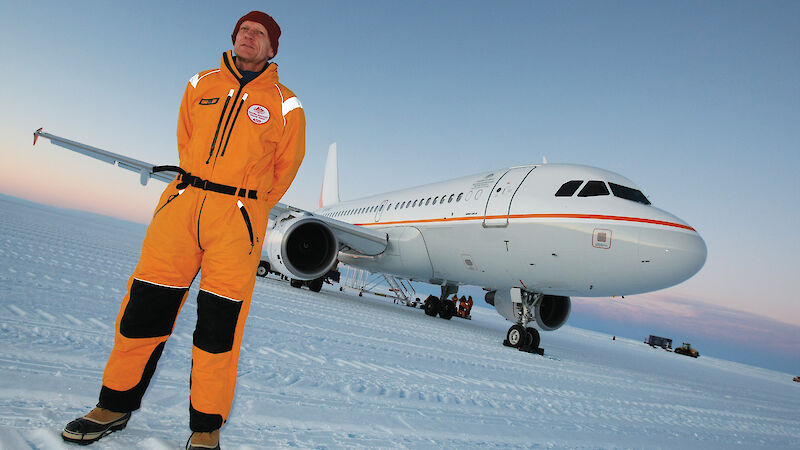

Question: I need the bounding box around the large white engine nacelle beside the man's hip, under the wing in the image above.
[264,216,339,280]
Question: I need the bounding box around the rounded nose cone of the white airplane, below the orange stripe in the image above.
[639,223,708,289]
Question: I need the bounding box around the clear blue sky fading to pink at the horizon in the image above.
[0,1,800,370]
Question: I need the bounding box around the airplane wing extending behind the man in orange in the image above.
[33,128,389,255]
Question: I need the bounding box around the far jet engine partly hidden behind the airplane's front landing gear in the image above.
[485,290,572,331]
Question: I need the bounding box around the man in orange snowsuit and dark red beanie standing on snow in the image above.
[62,11,305,448]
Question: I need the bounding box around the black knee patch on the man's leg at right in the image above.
[194,290,242,353]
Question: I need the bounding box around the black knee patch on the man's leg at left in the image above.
[119,279,188,338]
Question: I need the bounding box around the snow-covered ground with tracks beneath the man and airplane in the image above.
[0,196,800,449]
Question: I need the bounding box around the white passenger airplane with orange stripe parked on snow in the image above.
[34,129,707,354]
